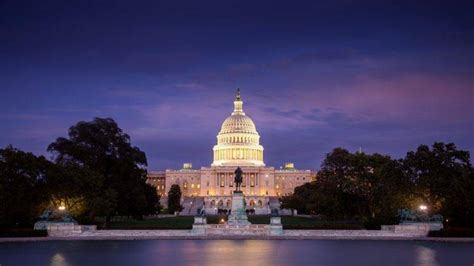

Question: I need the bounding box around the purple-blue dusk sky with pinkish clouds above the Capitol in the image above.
[0,0,474,170]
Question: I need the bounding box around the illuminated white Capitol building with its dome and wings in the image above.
[147,89,316,215]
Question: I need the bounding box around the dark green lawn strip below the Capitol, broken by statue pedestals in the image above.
[103,215,363,229]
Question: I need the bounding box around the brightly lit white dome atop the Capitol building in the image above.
[212,89,265,166]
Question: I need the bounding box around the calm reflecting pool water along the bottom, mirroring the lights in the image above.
[0,240,474,266]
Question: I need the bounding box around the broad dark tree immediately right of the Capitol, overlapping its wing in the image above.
[282,148,409,222]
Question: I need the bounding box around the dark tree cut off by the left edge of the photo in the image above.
[0,146,50,227]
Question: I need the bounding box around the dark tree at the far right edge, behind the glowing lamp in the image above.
[403,142,474,227]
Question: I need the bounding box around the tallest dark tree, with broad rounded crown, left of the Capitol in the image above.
[48,118,157,226]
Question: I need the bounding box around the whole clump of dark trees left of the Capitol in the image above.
[0,118,160,227]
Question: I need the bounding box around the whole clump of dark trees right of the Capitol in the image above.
[281,142,474,227]
